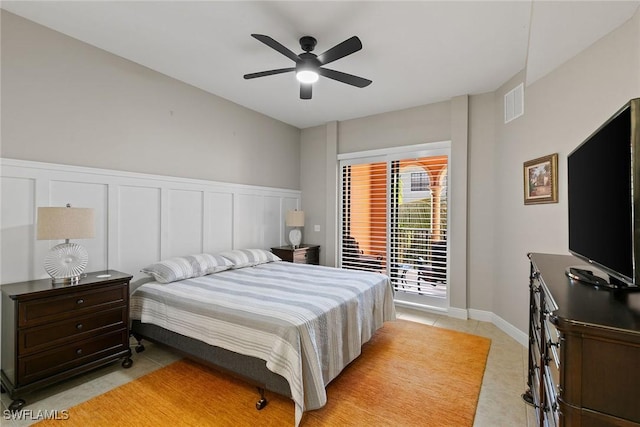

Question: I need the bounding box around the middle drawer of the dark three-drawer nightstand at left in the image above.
[18,307,127,356]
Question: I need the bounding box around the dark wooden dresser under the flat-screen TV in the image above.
[523,254,640,427]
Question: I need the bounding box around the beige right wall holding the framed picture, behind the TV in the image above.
[492,12,640,331]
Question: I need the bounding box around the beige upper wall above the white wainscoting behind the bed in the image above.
[0,10,300,189]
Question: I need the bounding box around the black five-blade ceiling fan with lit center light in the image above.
[244,34,371,99]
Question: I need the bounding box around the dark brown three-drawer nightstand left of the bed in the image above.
[0,270,132,411]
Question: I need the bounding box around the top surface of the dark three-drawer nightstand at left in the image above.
[0,270,133,299]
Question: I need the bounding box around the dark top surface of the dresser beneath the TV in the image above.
[530,253,640,334]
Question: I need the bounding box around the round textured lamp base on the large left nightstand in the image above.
[44,243,89,285]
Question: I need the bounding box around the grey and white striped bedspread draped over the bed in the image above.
[130,262,395,425]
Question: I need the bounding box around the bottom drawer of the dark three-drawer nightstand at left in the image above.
[18,328,129,384]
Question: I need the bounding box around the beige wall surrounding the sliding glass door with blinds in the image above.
[301,96,468,308]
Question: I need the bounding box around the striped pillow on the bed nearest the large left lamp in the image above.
[141,254,232,283]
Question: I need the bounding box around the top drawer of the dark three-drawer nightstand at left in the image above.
[18,284,128,327]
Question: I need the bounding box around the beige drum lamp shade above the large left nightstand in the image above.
[37,207,95,240]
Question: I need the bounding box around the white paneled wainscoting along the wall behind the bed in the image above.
[0,159,300,283]
